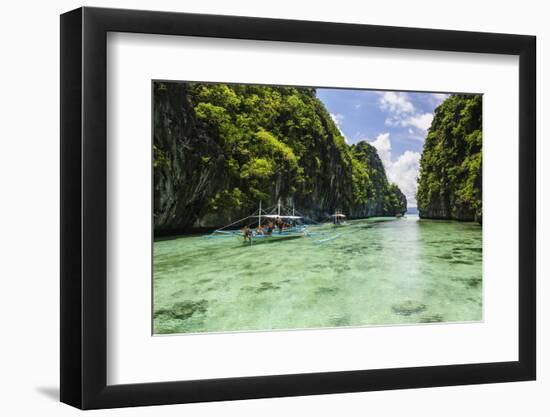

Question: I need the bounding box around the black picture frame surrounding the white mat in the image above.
[60,7,536,409]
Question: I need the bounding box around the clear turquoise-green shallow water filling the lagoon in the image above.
[153,216,482,334]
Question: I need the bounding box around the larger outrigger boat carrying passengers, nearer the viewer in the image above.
[207,201,308,245]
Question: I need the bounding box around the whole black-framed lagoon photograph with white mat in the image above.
[60,7,536,409]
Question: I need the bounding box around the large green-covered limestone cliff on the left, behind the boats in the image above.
[153,82,406,232]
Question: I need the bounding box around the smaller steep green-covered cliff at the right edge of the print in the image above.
[416,95,482,223]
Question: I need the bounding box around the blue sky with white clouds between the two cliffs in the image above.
[317,88,447,207]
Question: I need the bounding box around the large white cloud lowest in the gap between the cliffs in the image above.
[370,133,420,207]
